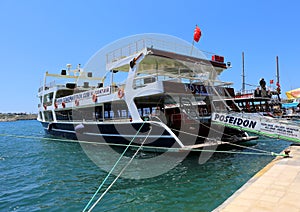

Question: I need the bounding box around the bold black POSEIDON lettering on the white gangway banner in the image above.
[214,113,257,129]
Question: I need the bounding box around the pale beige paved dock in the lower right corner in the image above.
[214,145,300,212]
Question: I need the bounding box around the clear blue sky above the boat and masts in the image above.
[0,0,300,113]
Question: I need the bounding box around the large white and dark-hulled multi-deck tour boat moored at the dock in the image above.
[38,34,257,149]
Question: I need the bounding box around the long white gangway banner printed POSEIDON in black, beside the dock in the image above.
[212,113,300,142]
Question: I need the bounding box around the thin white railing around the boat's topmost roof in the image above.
[106,38,215,67]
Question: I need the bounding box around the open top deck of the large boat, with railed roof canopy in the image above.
[106,37,230,80]
